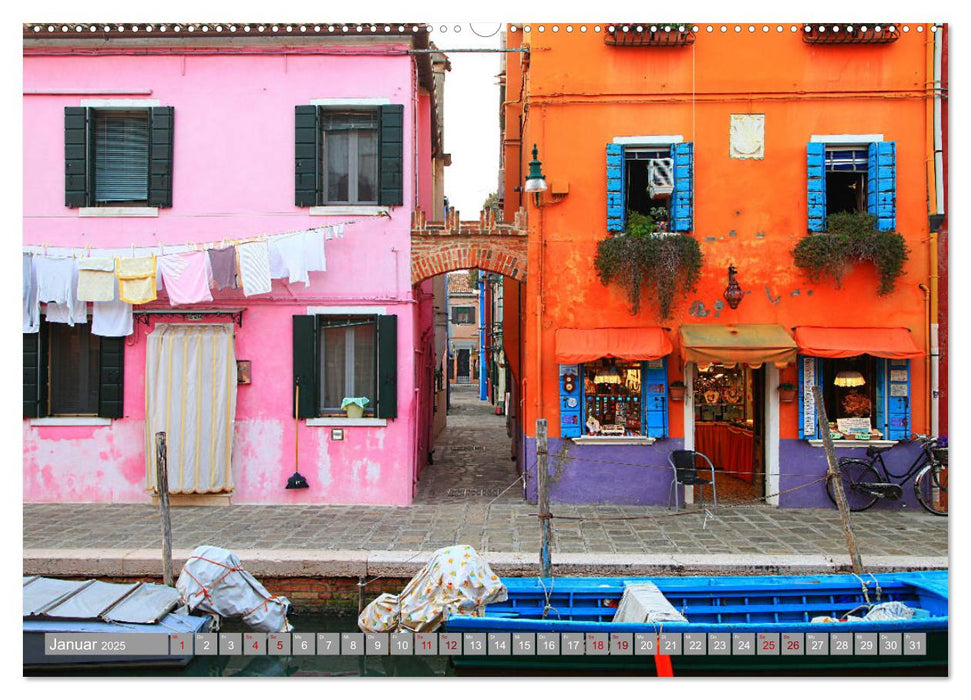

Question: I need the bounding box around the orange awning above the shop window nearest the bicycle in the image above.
[796,326,924,360]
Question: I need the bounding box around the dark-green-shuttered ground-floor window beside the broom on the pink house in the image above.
[293,314,398,418]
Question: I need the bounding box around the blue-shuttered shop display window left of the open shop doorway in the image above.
[560,358,668,438]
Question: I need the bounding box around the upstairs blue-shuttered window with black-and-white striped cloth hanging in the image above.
[607,143,694,232]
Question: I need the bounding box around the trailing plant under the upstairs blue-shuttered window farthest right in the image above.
[792,212,909,296]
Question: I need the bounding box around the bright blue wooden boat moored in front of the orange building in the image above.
[442,570,948,675]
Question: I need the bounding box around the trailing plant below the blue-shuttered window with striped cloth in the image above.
[594,207,702,319]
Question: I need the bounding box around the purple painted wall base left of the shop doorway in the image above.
[524,437,684,506]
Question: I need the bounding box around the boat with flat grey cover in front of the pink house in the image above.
[23,576,215,670]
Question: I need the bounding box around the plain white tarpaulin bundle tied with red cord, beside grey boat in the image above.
[175,546,293,632]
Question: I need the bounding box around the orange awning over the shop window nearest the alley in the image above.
[556,326,674,365]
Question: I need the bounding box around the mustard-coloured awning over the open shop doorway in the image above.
[681,323,796,367]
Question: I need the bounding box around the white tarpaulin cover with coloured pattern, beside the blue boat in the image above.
[357,544,508,632]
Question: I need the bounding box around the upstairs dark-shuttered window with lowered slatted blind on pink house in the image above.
[64,107,174,207]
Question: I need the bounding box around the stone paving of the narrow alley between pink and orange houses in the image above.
[415,384,523,504]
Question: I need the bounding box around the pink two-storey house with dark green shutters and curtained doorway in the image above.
[23,24,447,505]
